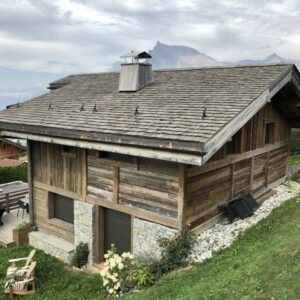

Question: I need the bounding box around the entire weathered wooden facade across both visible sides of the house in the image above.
[30,99,290,245]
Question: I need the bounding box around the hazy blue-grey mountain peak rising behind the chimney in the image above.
[111,42,223,71]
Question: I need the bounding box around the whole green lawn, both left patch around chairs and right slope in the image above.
[0,196,300,300]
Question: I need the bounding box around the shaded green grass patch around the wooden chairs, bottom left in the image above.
[0,247,105,300]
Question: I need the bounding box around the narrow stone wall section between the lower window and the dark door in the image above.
[74,201,96,263]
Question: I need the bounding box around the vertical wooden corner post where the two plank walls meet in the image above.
[177,164,187,230]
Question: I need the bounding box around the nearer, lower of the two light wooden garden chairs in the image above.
[4,261,36,299]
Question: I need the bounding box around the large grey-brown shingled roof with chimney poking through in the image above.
[0,64,298,157]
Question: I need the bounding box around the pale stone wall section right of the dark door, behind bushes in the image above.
[132,218,178,261]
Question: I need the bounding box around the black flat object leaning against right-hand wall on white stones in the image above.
[220,193,259,223]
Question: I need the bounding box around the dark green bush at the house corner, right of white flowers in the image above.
[150,227,196,277]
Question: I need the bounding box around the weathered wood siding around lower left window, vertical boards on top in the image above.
[31,142,86,242]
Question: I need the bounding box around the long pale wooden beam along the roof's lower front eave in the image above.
[0,130,202,166]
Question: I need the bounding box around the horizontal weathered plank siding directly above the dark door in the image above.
[87,151,179,225]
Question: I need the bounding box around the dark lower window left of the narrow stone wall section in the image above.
[49,193,74,224]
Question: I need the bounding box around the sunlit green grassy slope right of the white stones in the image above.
[128,196,300,300]
